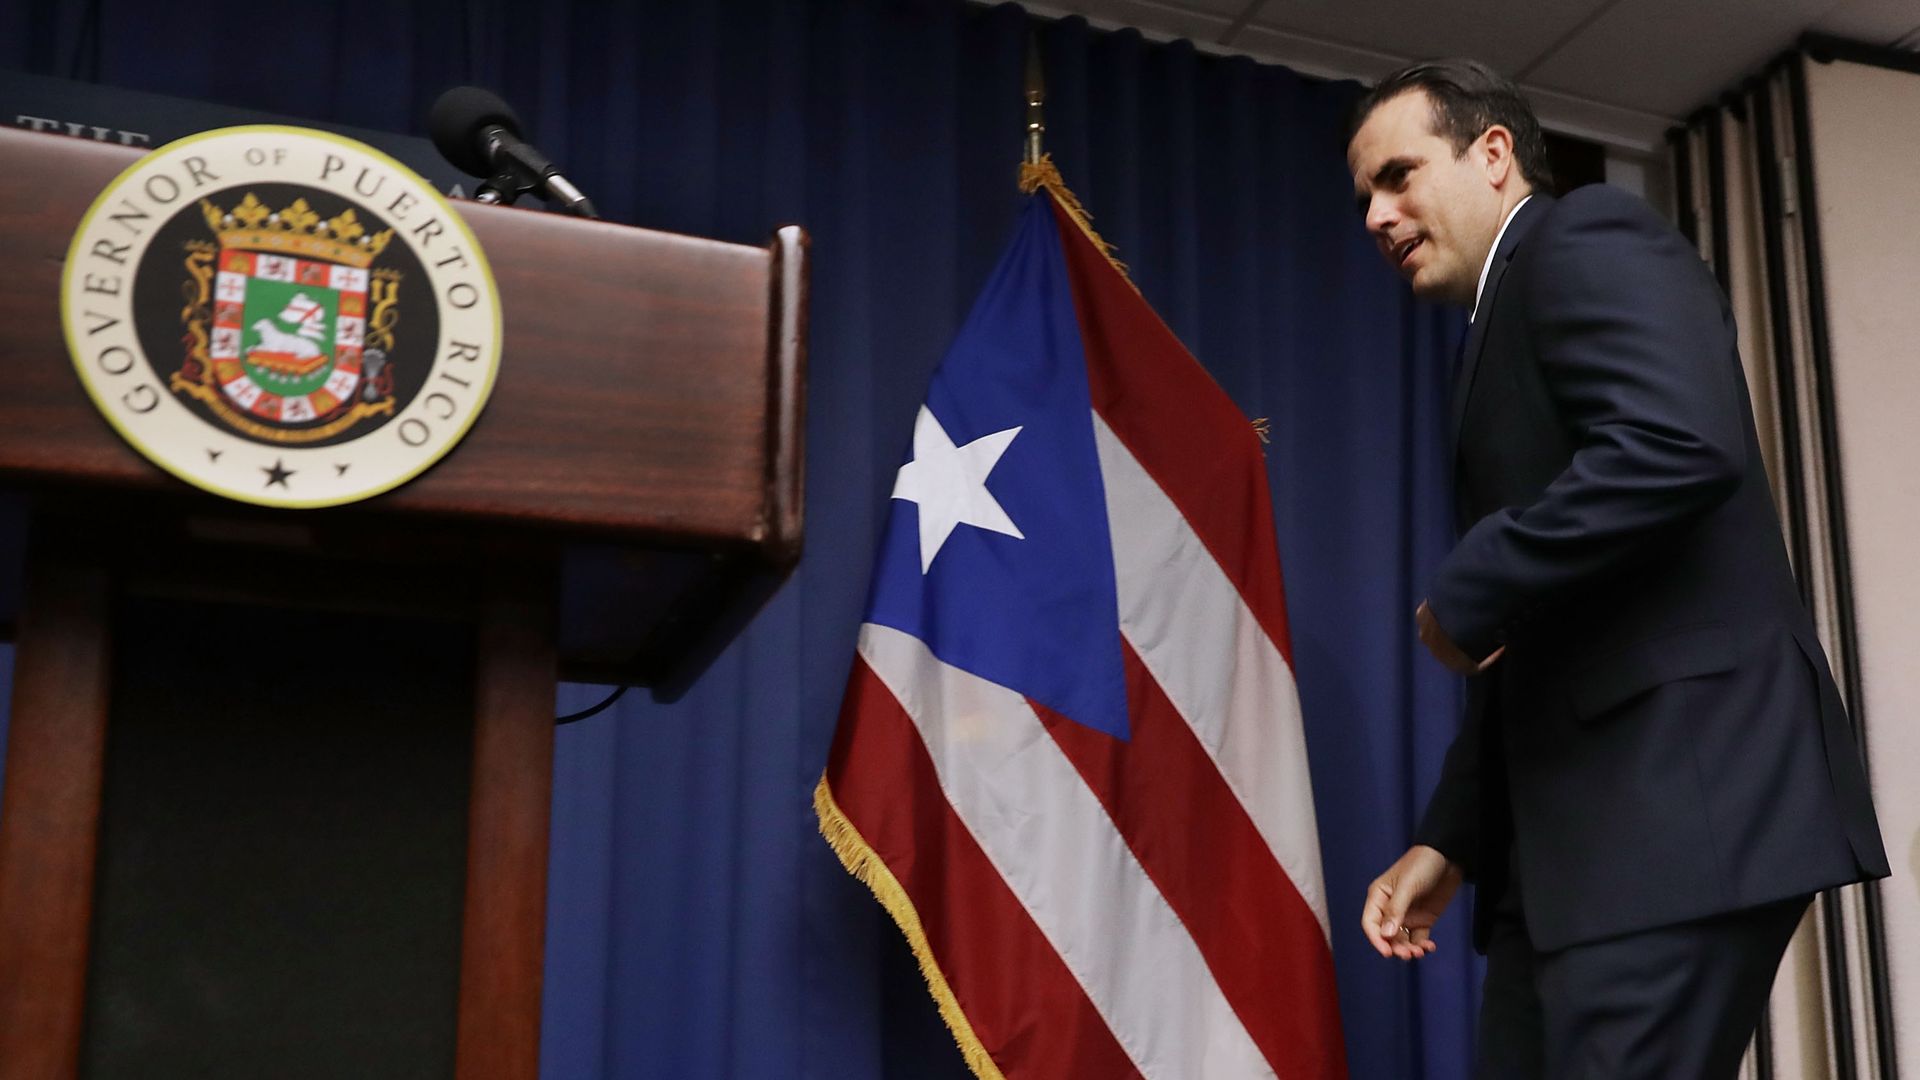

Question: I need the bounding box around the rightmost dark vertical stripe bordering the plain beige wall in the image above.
[1788,54,1899,1080]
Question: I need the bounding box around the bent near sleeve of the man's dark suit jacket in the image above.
[1428,186,1747,657]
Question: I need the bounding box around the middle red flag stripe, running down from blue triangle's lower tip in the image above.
[1033,644,1346,1080]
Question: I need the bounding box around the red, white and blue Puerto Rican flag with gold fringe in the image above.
[814,190,1346,1080]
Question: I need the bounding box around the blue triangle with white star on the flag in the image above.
[868,192,1127,738]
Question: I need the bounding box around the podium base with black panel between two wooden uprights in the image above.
[0,527,555,1080]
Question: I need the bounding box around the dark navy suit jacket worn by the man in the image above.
[1415,184,1887,949]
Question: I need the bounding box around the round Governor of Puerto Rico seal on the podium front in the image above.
[61,125,501,507]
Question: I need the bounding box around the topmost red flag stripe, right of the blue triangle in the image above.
[1054,200,1294,665]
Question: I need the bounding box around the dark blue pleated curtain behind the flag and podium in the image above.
[0,0,1478,1080]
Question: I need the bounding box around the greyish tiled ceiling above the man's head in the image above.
[1025,0,1920,154]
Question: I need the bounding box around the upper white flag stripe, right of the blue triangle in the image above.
[1092,413,1332,942]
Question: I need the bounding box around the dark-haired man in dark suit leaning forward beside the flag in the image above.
[1348,61,1887,1080]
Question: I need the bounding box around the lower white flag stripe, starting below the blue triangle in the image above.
[860,623,1273,1080]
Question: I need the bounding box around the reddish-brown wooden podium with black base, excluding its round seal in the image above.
[0,129,806,1080]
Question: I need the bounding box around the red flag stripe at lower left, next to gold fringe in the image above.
[828,657,1139,1080]
